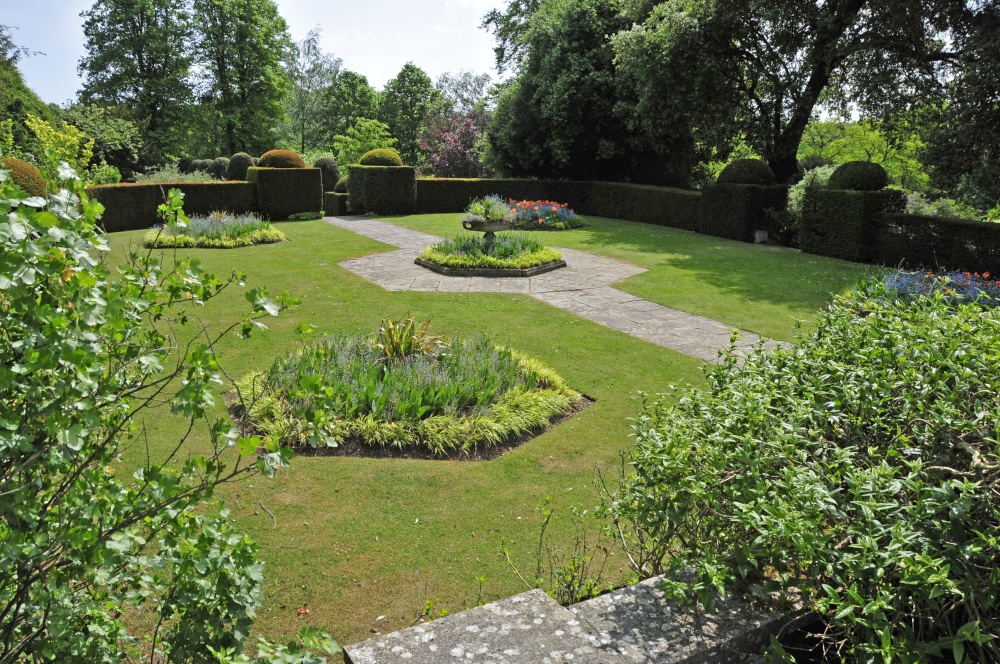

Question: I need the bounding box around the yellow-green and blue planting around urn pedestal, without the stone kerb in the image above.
[418,233,562,270]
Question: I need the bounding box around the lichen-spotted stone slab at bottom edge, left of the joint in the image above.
[344,590,627,664]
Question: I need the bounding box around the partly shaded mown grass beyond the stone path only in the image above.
[385,214,869,341]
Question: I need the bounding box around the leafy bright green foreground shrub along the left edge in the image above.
[0,163,340,662]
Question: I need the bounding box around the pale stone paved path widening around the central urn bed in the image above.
[326,217,777,362]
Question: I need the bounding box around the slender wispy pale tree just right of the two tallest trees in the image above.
[288,28,343,153]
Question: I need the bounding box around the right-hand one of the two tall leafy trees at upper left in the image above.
[194,0,292,154]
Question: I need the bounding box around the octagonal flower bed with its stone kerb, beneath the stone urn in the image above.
[417,232,566,277]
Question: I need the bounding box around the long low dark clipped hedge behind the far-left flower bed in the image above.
[87,182,257,233]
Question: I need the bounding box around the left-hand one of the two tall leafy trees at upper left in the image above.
[78,0,192,162]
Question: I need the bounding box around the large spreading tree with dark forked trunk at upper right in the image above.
[613,0,978,180]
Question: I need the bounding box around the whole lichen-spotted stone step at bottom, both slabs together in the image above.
[344,577,814,664]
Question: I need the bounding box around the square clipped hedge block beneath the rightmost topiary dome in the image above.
[799,189,904,263]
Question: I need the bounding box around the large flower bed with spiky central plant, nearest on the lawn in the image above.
[238,319,580,456]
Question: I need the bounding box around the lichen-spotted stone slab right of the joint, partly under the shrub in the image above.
[570,577,815,664]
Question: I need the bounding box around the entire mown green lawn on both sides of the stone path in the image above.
[103,215,862,643]
